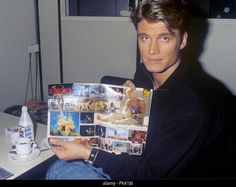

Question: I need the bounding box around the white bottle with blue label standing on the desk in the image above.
[18,106,34,140]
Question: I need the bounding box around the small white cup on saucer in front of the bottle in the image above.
[16,138,32,158]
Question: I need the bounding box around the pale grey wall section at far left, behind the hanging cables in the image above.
[0,0,36,111]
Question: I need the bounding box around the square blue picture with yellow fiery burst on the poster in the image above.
[49,111,79,136]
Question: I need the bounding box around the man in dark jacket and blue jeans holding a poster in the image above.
[47,0,232,179]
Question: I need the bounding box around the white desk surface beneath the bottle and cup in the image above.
[0,112,55,179]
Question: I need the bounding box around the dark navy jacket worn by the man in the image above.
[94,63,233,179]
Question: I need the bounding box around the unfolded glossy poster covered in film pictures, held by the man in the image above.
[47,83,152,155]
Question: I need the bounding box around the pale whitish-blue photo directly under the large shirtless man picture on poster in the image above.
[106,127,129,140]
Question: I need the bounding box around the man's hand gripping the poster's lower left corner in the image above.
[49,138,91,160]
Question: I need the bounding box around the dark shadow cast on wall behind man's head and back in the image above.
[182,4,236,174]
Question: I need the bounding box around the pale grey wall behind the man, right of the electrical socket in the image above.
[38,0,236,94]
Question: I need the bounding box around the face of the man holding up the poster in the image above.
[137,20,187,76]
